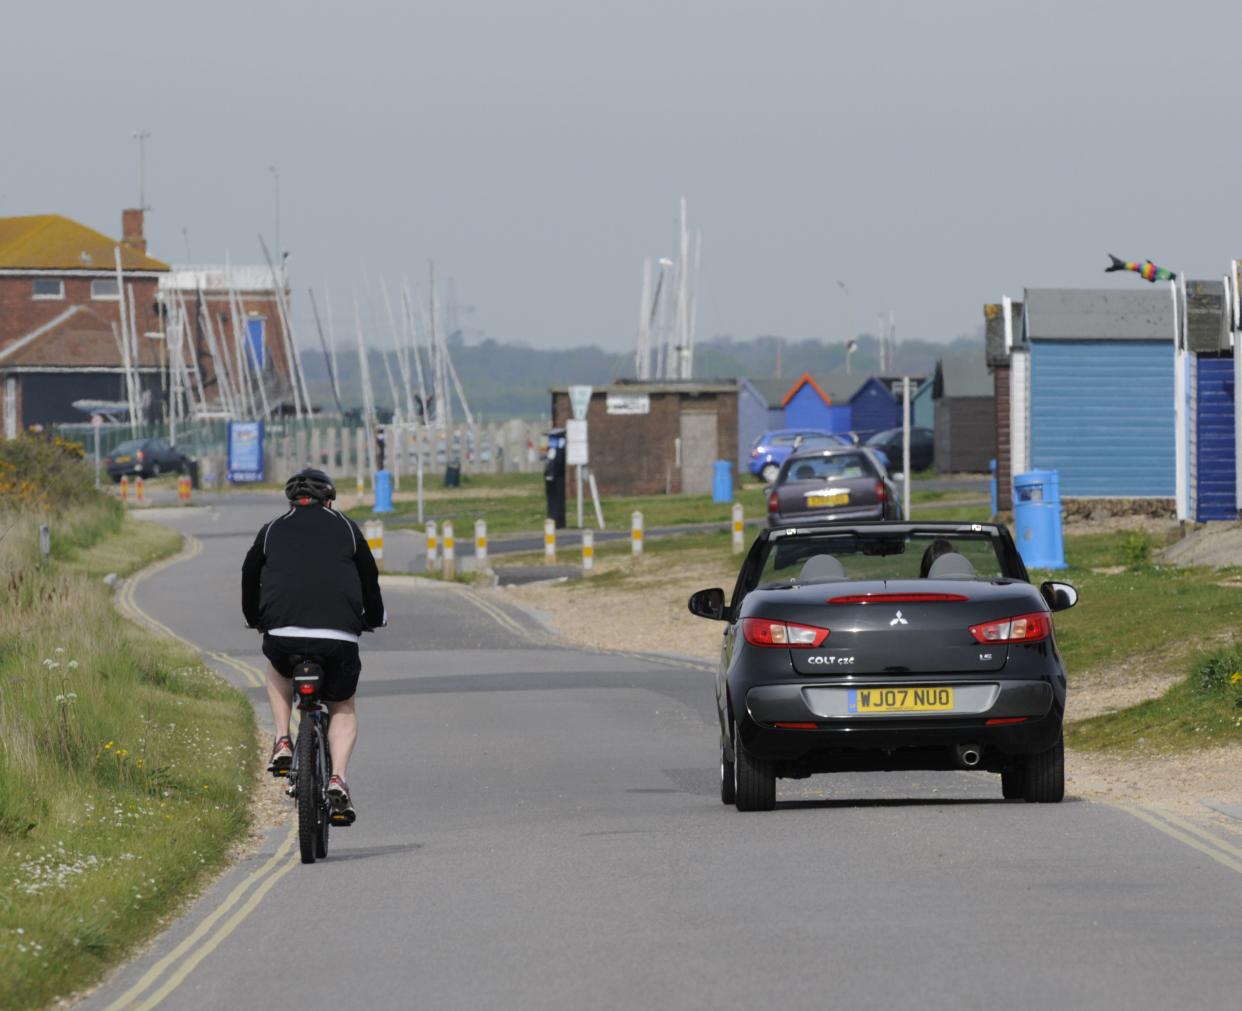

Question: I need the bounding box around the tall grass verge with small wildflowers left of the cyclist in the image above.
[0,501,256,1009]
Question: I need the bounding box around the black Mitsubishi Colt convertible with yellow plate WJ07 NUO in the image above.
[689,523,1078,811]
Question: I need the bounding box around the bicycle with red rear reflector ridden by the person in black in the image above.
[284,658,332,863]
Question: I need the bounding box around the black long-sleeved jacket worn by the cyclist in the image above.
[241,503,384,633]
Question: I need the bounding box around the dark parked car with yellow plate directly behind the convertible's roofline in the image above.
[768,446,902,527]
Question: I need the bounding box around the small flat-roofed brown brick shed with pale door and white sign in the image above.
[551,380,740,494]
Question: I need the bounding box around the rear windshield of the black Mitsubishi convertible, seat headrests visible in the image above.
[758,530,1010,589]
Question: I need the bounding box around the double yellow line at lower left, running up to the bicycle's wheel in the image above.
[104,828,297,1011]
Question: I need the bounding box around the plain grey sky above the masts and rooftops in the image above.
[0,0,1242,349]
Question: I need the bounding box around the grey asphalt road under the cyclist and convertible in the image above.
[81,499,1242,1011]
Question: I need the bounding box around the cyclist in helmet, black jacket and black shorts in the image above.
[241,468,388,825]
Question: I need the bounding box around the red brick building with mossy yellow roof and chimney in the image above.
[0,210,168,438]
